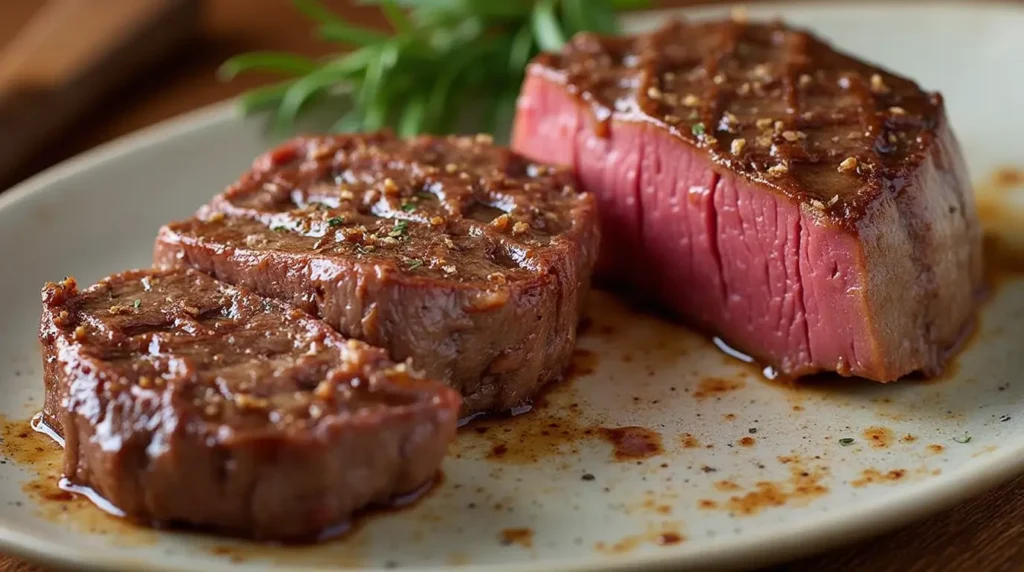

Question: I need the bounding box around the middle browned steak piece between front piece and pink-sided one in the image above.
[154,133,599,414]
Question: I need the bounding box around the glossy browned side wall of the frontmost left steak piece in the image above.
[40,271,459,540]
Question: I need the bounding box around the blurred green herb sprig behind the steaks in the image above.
[219,0,648,136]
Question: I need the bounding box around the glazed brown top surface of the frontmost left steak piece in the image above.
[41,270,458,439]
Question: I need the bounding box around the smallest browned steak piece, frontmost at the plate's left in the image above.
[39,270,460,540]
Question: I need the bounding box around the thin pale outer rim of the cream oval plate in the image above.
[0,0,1024,572]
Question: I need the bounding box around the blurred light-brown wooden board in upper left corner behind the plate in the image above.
[0,0,200,188]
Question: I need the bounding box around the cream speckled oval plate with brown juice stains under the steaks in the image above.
[0,3,1024,570]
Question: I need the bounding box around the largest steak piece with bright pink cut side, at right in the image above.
[513,21,981,382]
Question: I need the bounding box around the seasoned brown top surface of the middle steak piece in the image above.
[198,133,594,287]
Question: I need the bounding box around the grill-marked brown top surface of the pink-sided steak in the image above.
[530,20,943,221]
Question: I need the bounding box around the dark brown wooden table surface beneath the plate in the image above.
[0,0,1024,572]
